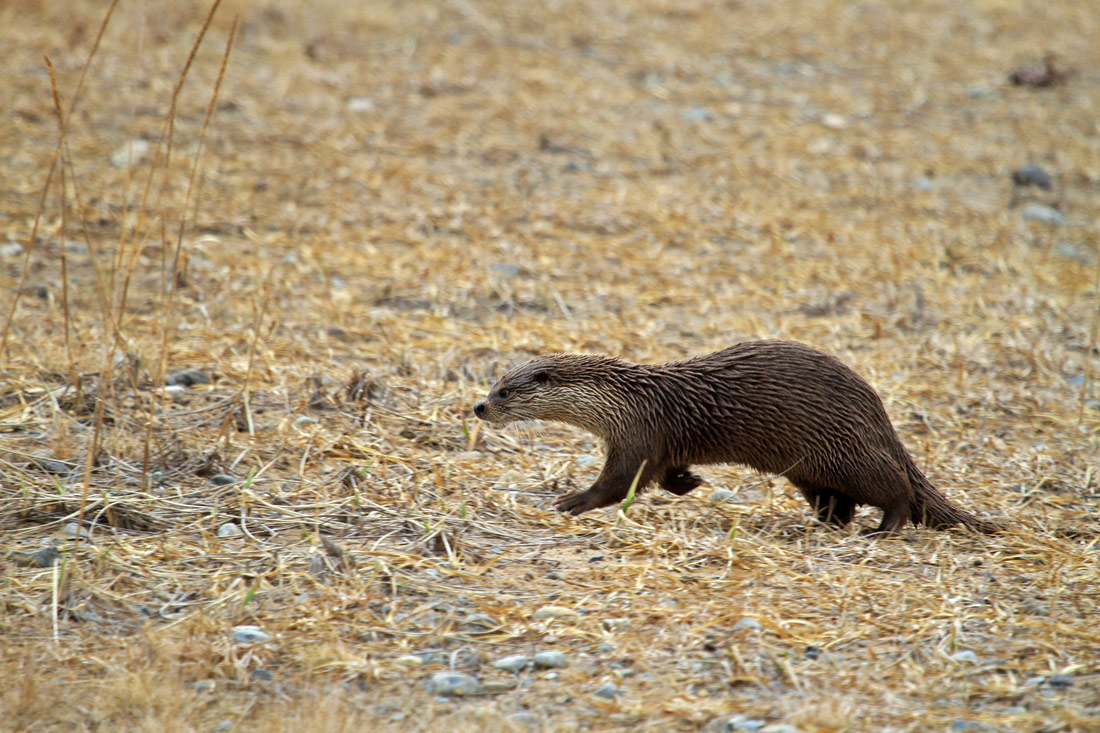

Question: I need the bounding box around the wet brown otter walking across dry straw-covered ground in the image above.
[474,341,998,536]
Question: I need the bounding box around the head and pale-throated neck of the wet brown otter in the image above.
[474,353,623,435]
